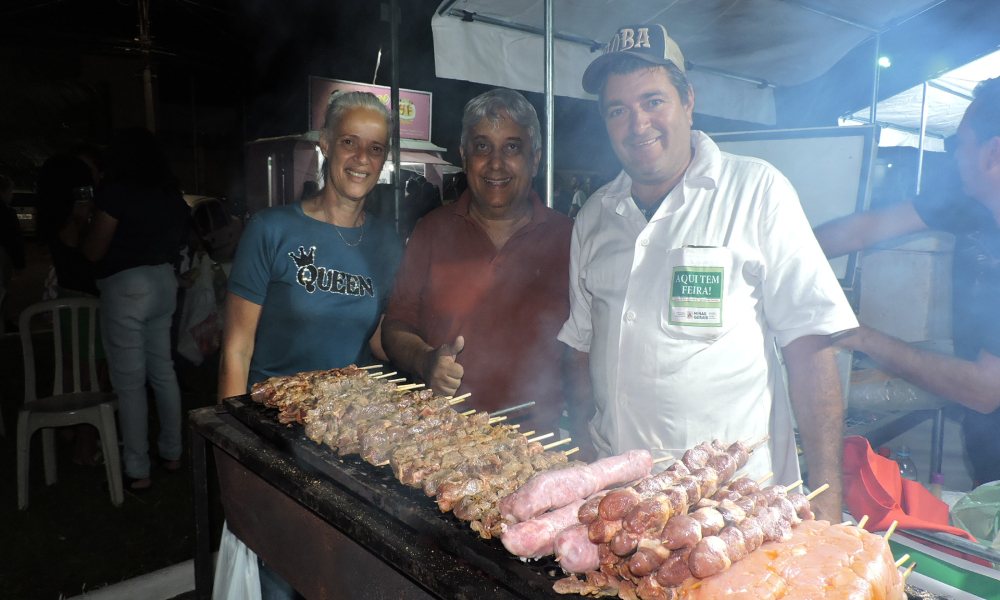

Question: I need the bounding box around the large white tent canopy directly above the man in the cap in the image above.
[431,0,940,125]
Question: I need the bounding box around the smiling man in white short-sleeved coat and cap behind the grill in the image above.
[559,25,858,520]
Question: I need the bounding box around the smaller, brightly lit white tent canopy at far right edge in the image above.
[841,51,1000,152]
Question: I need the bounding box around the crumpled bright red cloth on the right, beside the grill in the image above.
[843,436,976,542]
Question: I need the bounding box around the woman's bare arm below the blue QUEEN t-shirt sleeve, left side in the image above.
[218,292,261,402]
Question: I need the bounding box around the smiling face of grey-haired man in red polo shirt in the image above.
[462,110,542,217]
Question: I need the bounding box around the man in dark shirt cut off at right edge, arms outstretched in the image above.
[816,78,1000,484]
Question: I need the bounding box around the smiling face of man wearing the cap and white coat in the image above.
[602,67,694,202]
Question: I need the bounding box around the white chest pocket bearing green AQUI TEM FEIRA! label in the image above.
[660,247,738,341]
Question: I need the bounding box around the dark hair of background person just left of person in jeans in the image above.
[37,154,94,242]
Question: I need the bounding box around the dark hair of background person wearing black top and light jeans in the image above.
[108,127,180,192]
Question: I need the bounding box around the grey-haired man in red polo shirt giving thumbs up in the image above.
[382,89,573,434]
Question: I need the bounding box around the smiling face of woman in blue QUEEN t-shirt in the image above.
[320,107,389,202]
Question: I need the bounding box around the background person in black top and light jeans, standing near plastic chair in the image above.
[81,129,189,493]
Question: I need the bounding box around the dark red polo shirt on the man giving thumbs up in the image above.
[385,191,573,434]
